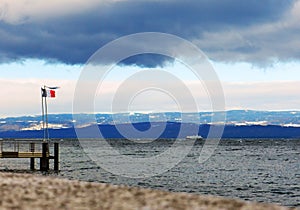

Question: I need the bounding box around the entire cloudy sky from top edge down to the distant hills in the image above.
[0,0,300,117]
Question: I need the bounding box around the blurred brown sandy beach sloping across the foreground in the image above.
[0,173,291,210]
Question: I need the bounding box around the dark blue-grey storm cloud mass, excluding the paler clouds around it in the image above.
[0,0,293,66]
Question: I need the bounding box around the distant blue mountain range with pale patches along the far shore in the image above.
[0,110,300,138]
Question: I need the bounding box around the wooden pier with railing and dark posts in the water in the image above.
[0,140,59,171]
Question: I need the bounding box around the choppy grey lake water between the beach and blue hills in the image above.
[0,139,300,206]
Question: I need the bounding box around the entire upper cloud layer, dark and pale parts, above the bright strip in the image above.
[0,0,300,66]
